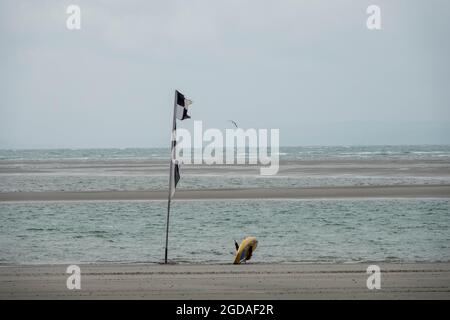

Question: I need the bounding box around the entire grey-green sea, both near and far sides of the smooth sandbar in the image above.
[0,145,450,265]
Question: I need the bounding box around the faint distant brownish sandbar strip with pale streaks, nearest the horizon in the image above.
[0,159,450,177]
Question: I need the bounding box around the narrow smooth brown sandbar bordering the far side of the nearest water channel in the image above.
[0,185,450,202]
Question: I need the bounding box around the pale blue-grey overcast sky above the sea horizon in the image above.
[0,0,450,149]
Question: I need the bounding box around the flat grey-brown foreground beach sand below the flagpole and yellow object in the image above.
[0,263,450,299]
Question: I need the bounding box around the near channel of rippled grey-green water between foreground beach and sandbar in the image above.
[0,199,450,264]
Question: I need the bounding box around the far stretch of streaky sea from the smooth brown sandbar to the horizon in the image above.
[0,146,450,192]
